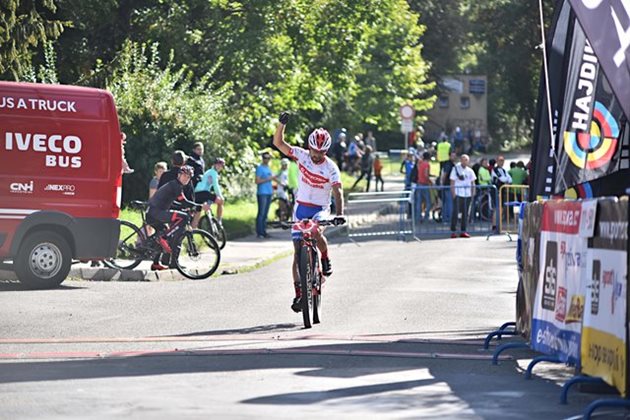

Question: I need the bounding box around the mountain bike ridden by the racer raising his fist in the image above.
[282,219,343,328]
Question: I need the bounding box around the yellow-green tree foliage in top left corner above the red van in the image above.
[0,0,68,79]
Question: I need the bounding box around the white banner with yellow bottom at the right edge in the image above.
[581,199,628,397]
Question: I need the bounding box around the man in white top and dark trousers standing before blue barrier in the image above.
[450,155,476,238]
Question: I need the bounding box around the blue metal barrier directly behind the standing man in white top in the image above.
[412,185,497,239]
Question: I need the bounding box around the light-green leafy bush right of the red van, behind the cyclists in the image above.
[107,42,254,200]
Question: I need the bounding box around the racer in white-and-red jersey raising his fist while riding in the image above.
[273,112,345,312]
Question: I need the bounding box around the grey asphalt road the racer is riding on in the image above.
[0,237,616,419]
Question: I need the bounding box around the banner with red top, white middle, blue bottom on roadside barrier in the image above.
[531,201,587,364]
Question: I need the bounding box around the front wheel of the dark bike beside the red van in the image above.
[175,229,221,280]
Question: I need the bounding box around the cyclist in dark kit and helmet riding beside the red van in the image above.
[147,165,209,270]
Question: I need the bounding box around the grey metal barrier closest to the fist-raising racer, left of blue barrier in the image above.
[346,191,414,239]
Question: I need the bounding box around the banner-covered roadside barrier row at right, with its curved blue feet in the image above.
[508,198,630,415]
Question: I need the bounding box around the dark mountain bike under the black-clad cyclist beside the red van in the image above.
[103,201,221,280]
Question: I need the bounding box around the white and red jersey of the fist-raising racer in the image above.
[289,147,341,207]
